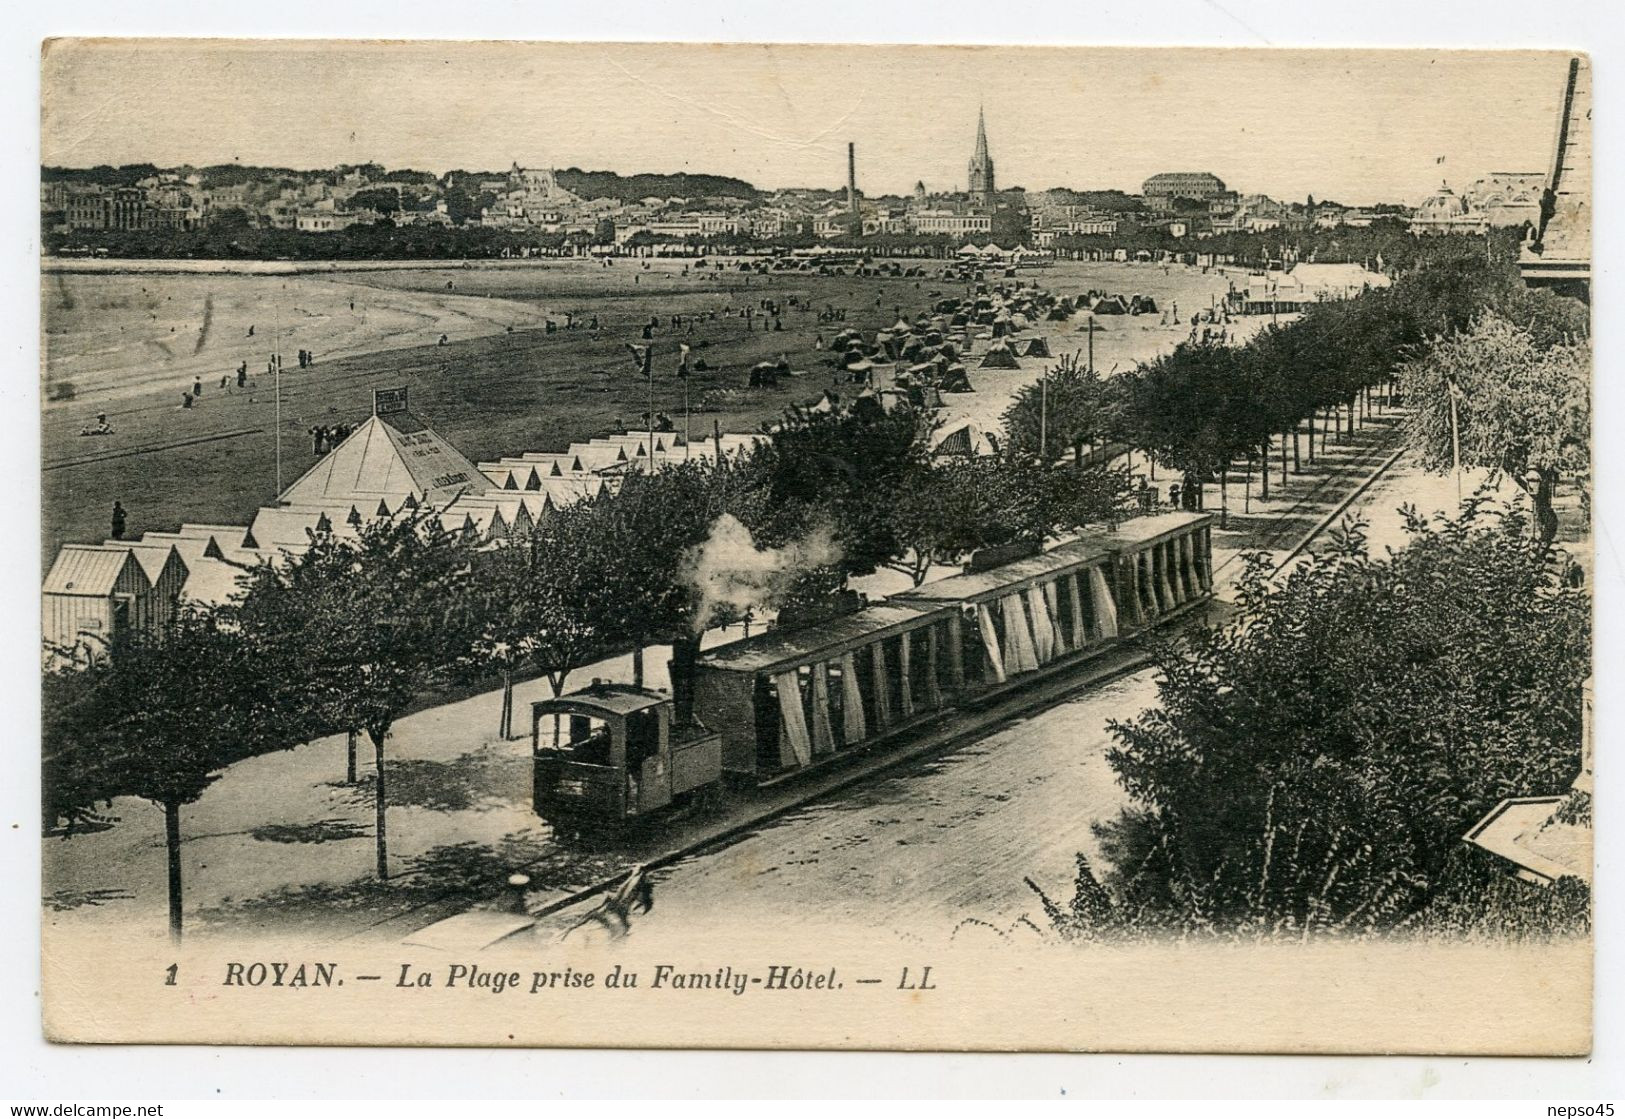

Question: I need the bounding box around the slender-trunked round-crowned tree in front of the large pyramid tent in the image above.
[241,508,473,880]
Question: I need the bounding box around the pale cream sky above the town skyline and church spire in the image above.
[41,39,1567,205]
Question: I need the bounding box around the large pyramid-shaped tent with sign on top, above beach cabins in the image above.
[281,388,496,505]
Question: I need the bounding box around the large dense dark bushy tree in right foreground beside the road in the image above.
[1100,503,1591,937]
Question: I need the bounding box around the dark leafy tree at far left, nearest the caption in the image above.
[44,609,297,942]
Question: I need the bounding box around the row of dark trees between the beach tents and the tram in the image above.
[44,397,1126,937]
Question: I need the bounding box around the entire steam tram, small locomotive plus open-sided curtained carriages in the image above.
[531,513,1212,820]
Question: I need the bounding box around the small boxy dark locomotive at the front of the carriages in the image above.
[531,682,722,820]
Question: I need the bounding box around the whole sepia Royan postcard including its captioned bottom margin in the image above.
[39,39,1593,1054]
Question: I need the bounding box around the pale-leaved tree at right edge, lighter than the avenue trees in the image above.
[1399,312,1591,544]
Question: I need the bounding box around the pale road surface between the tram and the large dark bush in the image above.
[533,671,1155,939]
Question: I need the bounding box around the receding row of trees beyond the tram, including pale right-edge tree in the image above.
[1004,245,1589,539]
